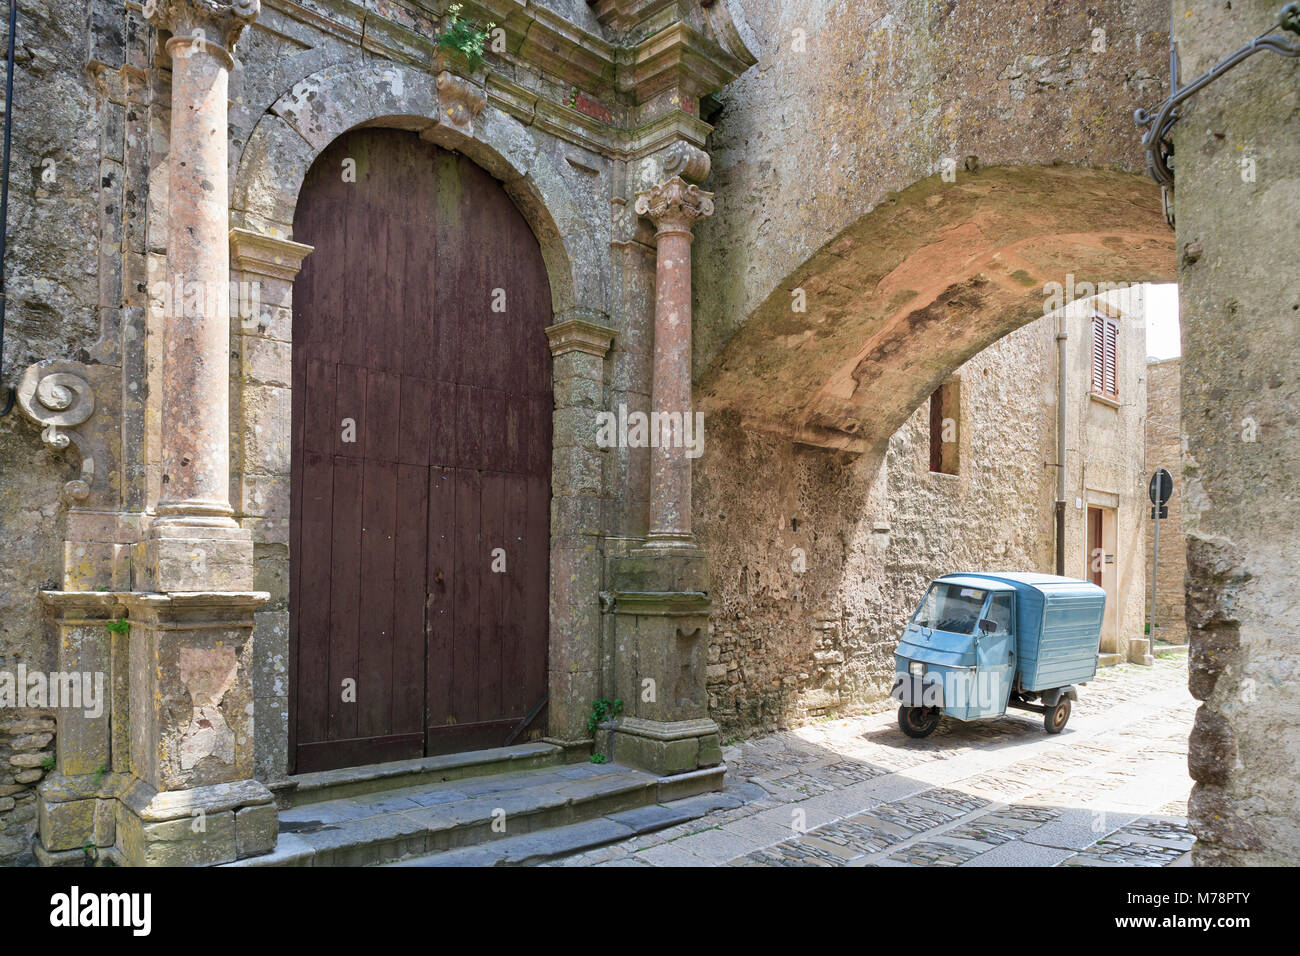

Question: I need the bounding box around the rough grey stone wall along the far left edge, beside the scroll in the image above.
[0,3,101,864]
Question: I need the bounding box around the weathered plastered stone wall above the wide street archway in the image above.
[696,0,1169,373]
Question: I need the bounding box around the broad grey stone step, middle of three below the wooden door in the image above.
[230,763,725,866]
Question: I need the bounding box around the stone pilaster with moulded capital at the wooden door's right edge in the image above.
[546,315,615,743]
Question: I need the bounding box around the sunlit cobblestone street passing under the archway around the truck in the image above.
[549,654,1195,866]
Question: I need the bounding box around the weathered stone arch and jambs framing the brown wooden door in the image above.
[231,64,614,779]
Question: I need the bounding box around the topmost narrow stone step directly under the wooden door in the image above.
[282,743,566,809]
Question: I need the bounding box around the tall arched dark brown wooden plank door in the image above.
[290,129,551,773]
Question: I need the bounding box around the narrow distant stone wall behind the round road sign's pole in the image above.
[1147,359,1187,644]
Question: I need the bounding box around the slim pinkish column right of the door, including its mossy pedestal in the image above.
[610,166,725,799]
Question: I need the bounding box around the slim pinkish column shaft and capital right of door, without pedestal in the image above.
[636,176,714,551]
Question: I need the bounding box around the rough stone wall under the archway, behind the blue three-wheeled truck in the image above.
[696,293,1145,736]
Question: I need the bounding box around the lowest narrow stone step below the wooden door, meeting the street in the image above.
[386,792,745,866]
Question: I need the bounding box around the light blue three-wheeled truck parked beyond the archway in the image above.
[891,572,1106,737]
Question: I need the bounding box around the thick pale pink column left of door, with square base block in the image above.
[144,0,260,592]
